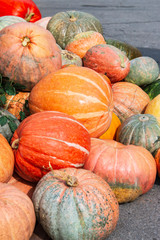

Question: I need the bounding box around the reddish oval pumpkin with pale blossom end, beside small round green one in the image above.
[83,44,130,83]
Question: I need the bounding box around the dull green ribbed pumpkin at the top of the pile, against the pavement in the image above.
[47,10,103,49]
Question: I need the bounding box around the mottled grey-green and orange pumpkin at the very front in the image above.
[32,168,119,240]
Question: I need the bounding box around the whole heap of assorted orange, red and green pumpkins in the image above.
[0,0,160,240]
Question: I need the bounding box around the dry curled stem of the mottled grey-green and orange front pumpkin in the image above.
[49,162,78,187]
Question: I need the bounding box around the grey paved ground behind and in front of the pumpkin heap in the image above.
[30,0,160,240]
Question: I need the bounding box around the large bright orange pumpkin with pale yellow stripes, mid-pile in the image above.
[28,66,113,137]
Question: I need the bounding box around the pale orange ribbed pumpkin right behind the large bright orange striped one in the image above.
[112,82,150,122]
